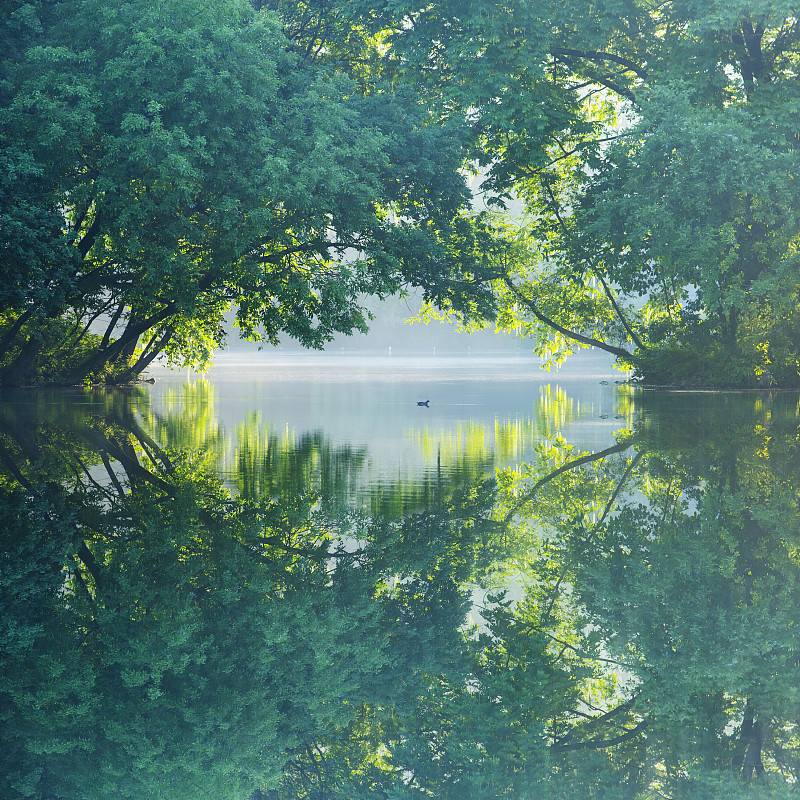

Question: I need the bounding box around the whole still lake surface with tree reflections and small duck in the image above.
[0,356,800,800]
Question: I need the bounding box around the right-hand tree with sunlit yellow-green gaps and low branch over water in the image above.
[395,0,800,386]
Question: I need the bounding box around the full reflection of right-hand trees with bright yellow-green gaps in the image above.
[376,396,800,800]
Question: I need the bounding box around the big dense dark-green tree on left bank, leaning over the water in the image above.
[0,0,486,385]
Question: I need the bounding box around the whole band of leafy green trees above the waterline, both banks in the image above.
[0,0,800,388]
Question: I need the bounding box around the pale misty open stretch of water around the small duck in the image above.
[150,352,627,494]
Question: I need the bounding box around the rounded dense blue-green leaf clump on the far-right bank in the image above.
[562,86,800,385]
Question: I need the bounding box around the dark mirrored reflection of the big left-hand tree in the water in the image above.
[0,394,491,800]
